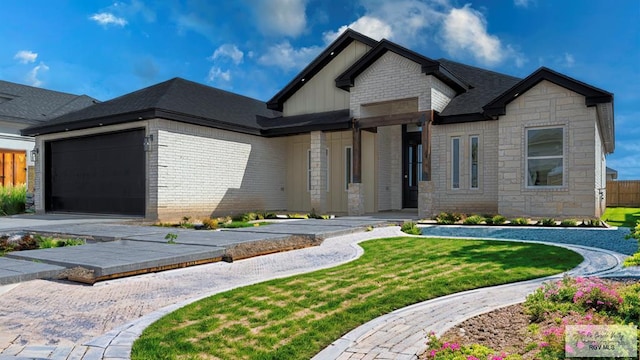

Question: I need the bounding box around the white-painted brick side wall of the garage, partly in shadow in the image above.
[149,120,286,219]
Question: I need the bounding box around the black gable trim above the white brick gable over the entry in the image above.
[336,39,469,93]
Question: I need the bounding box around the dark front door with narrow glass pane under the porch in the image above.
[402,132,422,208]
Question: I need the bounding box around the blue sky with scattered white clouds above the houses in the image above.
[0,0,640,179]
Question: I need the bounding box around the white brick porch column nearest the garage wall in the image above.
[309,131,329,214]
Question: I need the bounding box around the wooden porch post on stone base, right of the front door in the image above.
[418,110,435,219]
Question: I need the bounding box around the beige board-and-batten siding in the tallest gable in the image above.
[283,41,371,116]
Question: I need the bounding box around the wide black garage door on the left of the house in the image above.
[45,129,145,216]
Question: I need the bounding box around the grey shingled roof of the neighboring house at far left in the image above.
[0,80,97,127]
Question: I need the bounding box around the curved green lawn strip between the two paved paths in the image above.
[132,237,582,359]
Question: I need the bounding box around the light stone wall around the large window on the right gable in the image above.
[498,81,599,219]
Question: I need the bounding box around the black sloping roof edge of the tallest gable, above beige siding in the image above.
[267,29,378,111]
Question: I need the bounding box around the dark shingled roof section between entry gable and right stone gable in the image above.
[438,59,521,123]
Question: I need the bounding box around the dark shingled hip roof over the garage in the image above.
[22,78,280,135]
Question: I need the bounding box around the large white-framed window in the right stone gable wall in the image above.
[526,128,564,187]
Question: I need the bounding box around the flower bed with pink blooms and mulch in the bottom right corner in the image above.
[421,277,640,360]
